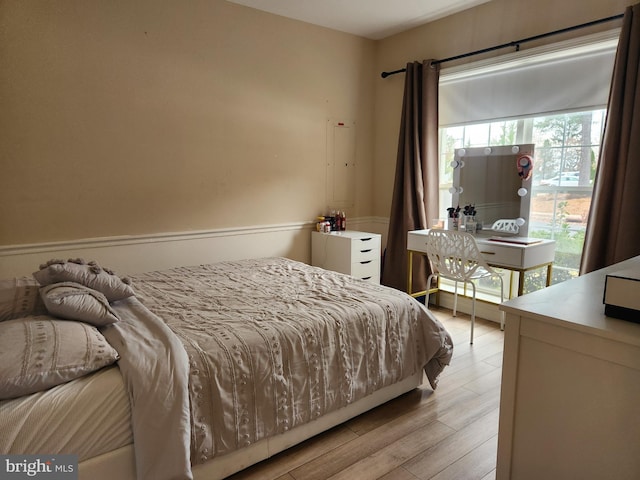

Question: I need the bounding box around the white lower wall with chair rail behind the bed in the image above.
[0,217,386,278]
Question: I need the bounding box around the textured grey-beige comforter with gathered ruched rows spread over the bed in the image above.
[120,258,452,478]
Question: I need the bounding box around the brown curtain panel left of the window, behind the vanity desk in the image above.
[382,60,440,291]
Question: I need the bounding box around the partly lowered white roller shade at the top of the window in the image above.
[439,29,620,127]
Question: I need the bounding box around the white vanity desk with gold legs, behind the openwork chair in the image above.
[407,229,555,296]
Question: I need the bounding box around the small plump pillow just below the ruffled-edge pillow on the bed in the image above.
[40,282,120,327]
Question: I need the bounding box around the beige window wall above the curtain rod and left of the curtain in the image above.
[374,0,637,217]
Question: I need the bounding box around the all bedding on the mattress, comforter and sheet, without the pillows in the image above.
[0,258,452,480]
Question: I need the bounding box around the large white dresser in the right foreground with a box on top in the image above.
[496,257,640,480]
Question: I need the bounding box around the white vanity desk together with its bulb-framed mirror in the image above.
[407,144,555,341]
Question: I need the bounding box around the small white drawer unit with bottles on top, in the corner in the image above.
[311,230,381,283]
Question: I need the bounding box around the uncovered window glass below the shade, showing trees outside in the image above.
[440,109,605,292]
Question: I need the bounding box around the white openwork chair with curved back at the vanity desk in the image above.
[425,230,504,344]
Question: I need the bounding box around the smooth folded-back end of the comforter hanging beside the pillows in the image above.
[102,297,193,480]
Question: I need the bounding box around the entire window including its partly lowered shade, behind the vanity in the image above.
[439,30,620,295]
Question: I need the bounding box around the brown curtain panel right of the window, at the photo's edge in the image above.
[580,4,640,274]
